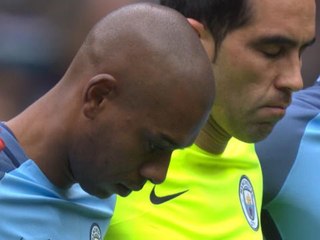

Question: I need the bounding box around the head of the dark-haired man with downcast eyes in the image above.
[161,0,315,142]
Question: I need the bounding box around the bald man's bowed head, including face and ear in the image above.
[38,3,215,197]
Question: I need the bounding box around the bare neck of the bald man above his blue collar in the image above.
[6,94,73,188]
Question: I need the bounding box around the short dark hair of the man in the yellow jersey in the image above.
[160,0,252,50]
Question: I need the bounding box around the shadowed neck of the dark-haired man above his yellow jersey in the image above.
[195,116,231,154]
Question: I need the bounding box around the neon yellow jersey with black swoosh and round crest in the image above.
[105,139,263,240]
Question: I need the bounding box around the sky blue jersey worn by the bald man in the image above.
[0,123,115,240]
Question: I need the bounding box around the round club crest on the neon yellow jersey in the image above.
[239,176,259,231]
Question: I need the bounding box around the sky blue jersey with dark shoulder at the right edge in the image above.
[256,77,320,240]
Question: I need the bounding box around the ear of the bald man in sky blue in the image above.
[83,74,118,119]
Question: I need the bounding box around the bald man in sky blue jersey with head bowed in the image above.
[0,4,214,240]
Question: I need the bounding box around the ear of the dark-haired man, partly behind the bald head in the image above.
[187,18,215,61]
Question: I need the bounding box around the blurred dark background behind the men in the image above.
[0,0,320,121]
